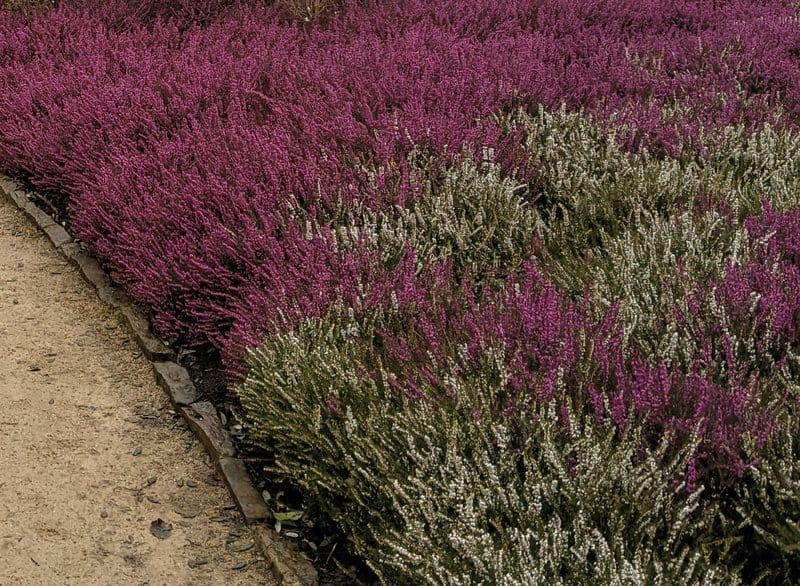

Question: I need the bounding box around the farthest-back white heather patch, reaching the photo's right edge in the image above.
[501,109,800,276]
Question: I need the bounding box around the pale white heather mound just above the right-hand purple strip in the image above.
[570,210,748,366]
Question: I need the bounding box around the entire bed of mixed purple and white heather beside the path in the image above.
[0,0,800,584]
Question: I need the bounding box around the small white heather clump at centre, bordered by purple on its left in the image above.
[330,150,537,277]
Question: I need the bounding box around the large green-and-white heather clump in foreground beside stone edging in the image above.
[239,319,736,585]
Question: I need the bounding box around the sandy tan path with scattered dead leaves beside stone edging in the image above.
[0,198,275,586]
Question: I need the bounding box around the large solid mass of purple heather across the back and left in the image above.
[0,0,798,360]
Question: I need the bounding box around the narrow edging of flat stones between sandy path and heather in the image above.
[0,176,319,586]
